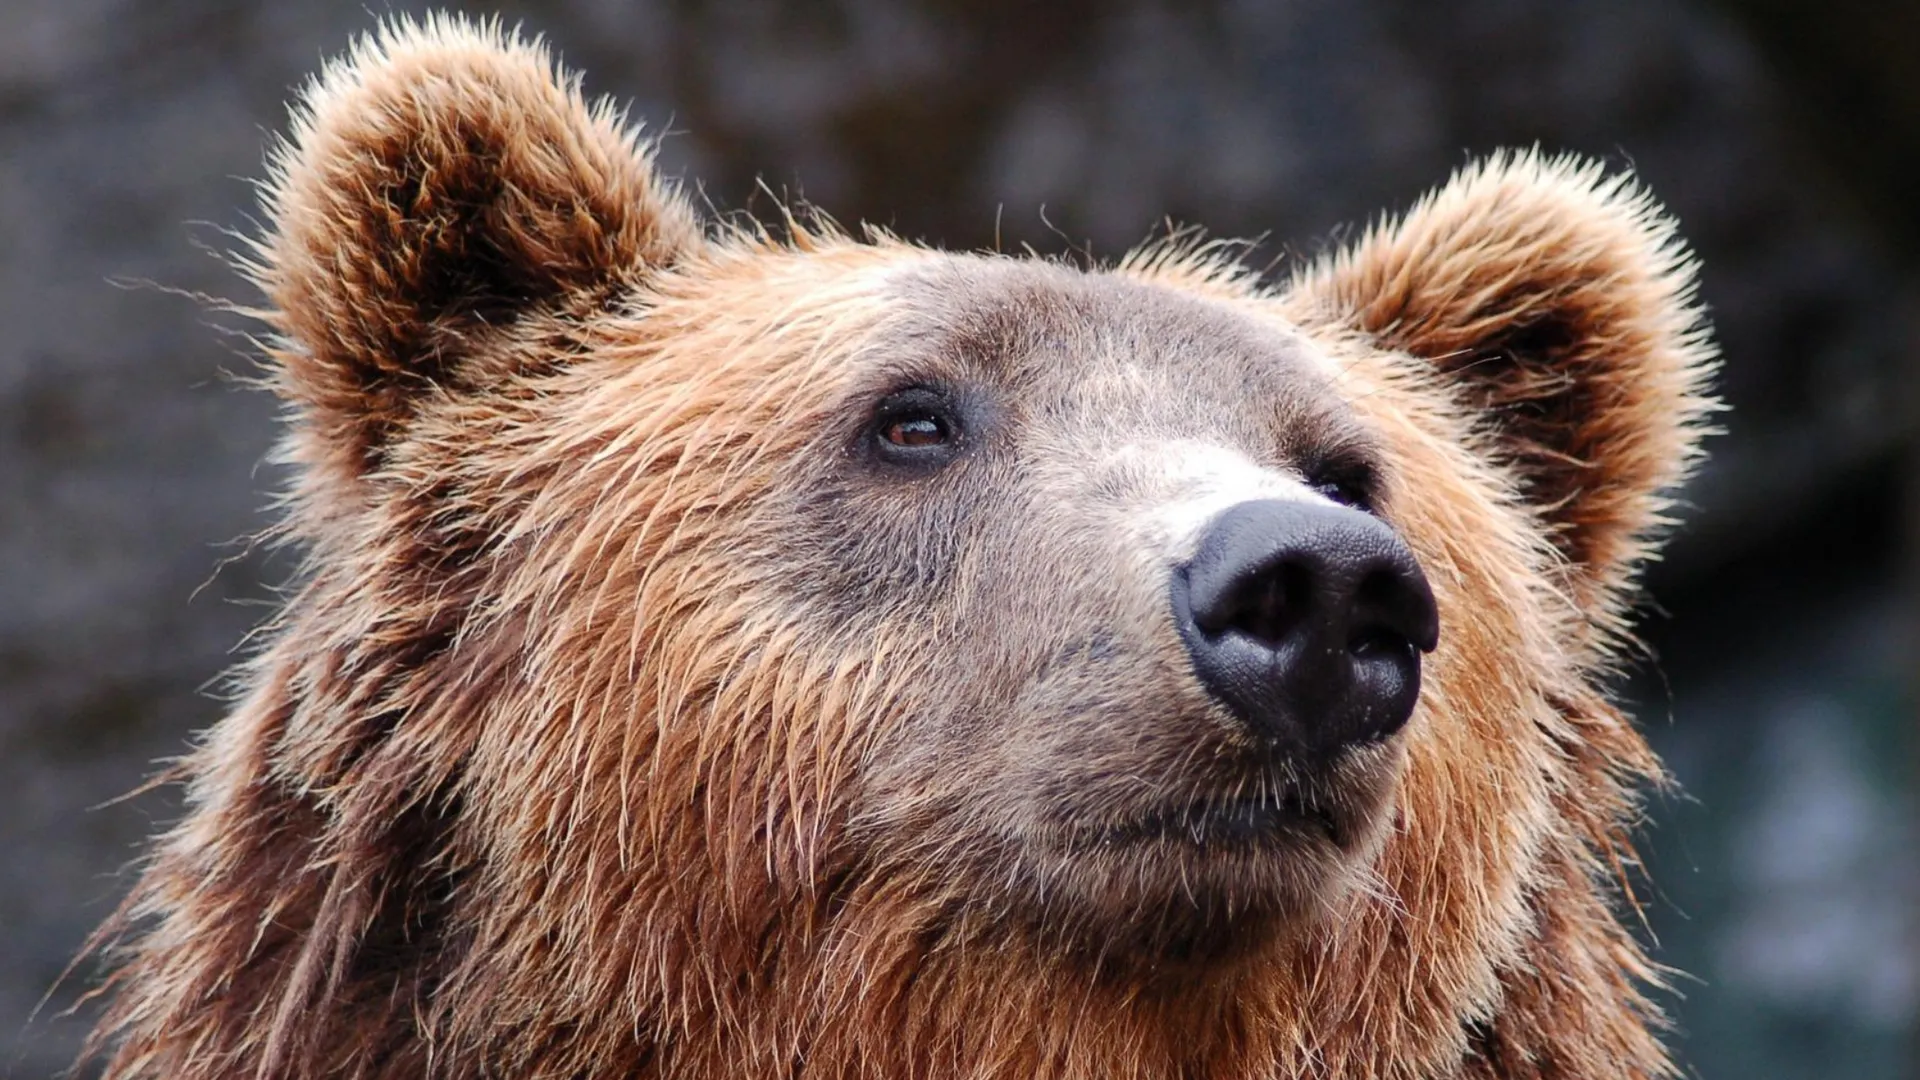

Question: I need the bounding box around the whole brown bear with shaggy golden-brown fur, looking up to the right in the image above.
[82,19,1713,1080]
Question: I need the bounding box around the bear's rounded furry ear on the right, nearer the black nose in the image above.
[1288,154,1716,617]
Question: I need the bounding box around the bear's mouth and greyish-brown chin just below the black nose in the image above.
[1016,736,1405,960]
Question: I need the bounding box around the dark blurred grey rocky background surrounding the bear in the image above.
[0,0,1920,1080]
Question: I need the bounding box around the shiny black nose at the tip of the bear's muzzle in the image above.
[1173,500,1440,753]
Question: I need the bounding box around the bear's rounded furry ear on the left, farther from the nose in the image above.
[242,17,703,469]
